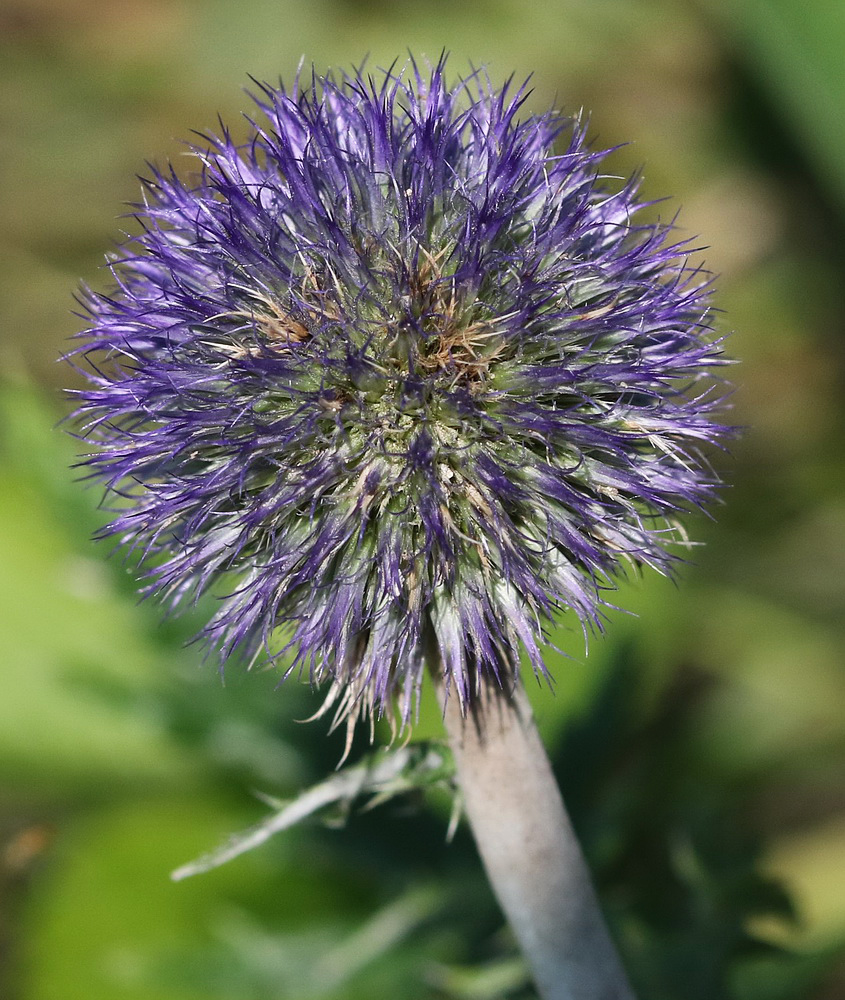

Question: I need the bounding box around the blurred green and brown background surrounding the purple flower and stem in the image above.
[0,0,845,1000]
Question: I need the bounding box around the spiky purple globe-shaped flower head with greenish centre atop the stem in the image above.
[72,61,724,720]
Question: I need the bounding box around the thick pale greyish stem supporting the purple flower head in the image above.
[444,685,634,1000]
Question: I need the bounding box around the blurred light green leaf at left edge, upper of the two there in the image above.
[0,387,193,797]
